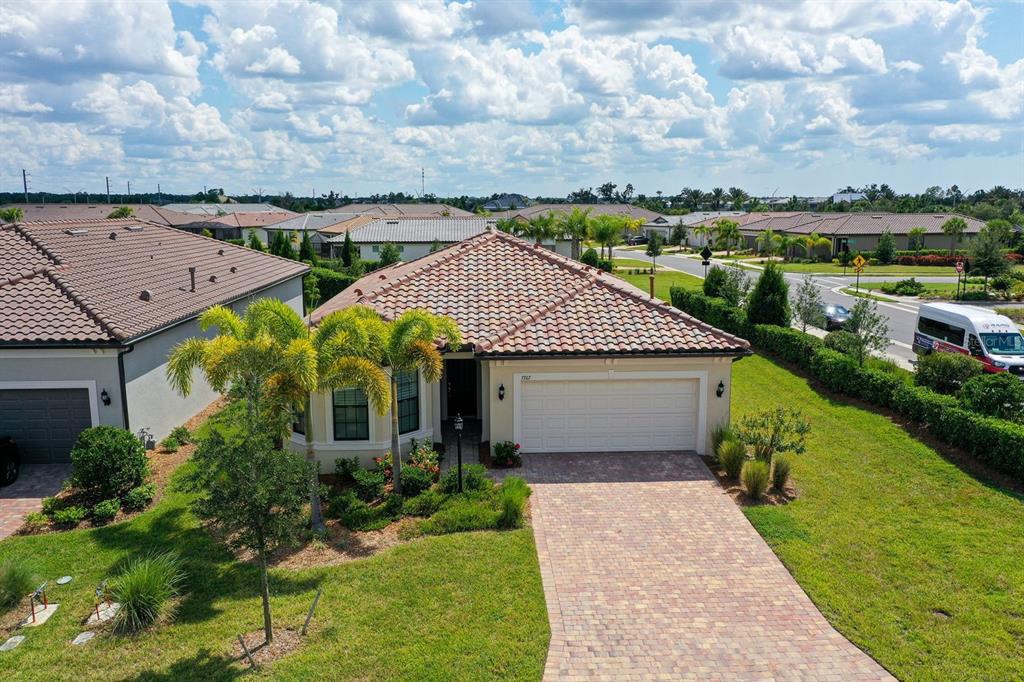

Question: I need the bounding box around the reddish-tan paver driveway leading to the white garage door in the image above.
[521,453,892,681]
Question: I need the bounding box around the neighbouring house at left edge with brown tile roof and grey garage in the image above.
[0,218,308,464]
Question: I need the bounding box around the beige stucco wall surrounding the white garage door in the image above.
[482,357,732,455]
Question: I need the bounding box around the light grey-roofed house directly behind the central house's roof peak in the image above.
[325,216,572,261]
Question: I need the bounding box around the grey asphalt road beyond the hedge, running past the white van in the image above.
[614,250,929,366]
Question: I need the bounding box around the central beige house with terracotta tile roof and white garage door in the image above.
[292,229,751,468]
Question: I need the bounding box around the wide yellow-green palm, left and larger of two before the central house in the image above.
[167,298,389,530]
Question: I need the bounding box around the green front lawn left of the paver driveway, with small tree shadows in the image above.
[0,458,550,680]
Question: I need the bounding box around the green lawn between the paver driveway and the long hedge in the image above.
[732,356,1024,680]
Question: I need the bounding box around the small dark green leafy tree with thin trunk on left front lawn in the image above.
[184,431,313,643]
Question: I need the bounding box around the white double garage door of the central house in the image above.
[519,377,699,453]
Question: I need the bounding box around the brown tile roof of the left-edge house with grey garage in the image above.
[0,218,308,344]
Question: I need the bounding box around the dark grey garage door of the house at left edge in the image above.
[0,388,92,464]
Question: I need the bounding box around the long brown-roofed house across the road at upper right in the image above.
[739,212,985,254]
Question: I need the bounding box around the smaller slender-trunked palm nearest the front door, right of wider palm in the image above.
[369,309,462,495]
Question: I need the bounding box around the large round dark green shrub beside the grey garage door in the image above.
[71,426,150,500]
